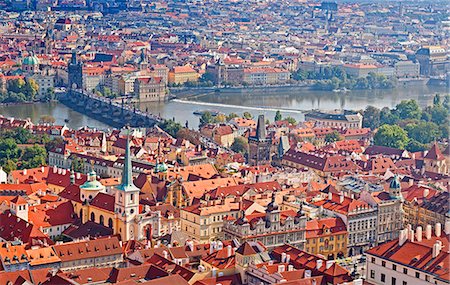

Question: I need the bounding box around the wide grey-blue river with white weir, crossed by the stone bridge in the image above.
[0,86,448,129]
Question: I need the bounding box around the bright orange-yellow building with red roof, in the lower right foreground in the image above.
[305,218,348,260]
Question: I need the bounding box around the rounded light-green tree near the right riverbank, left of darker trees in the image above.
[373,125,408,149]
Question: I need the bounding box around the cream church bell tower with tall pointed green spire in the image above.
[114,135,139,241]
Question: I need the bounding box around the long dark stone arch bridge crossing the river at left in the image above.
[60,90,162,128]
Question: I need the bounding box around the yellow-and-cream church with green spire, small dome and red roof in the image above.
[60,134,161,241]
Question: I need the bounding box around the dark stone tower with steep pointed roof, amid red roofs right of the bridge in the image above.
[248,115,271,165]
